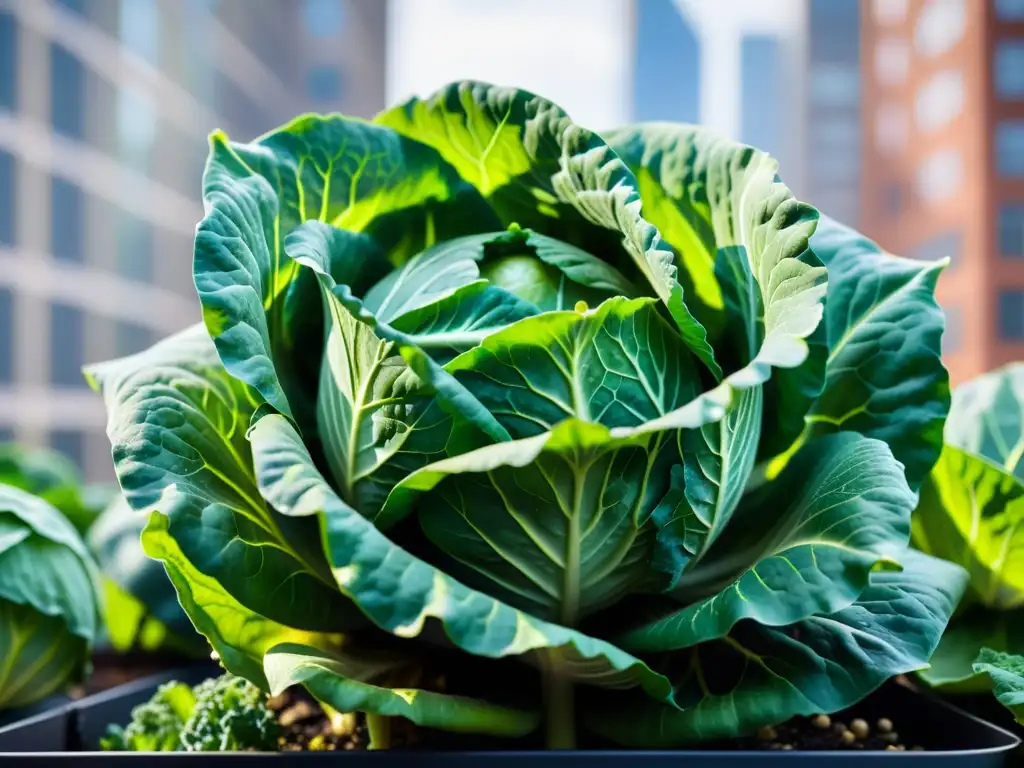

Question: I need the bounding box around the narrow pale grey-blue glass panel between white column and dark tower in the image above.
[739,35,785,162]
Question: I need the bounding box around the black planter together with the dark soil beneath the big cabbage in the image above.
[0,665,1020,768]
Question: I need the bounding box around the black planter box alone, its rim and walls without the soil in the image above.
[0,665,1021,768]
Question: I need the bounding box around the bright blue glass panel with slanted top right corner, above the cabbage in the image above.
[633,0,700,123]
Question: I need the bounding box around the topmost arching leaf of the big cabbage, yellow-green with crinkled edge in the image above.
[375,81,722,378]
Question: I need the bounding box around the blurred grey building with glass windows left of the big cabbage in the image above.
[0,0,387,477]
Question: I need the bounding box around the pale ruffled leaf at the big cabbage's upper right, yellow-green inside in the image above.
[606,123,826,462]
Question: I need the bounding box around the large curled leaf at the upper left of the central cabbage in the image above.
[195,116,500,434]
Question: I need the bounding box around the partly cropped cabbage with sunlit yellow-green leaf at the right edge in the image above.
[912,362,1024,691]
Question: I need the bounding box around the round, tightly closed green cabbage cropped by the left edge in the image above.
[0,483,99,710]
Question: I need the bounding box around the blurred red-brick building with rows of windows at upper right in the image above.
[861,0,1024,384]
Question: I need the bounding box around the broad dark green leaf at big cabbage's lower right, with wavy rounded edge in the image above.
[615,433,914,652]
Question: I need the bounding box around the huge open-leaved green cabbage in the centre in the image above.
[88,82,966,748]
